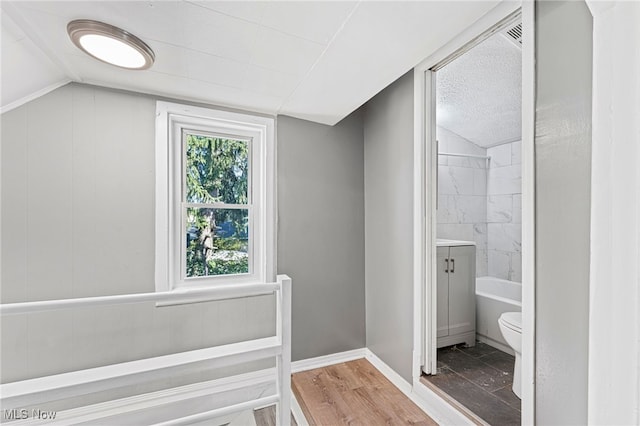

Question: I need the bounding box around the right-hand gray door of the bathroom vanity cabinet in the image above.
[448,246,476,335]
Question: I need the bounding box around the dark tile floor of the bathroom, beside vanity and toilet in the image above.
[422,342,520,426]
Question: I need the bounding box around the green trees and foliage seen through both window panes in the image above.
[184,133,249,277]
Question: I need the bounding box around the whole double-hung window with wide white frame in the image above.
[156,102,275,291]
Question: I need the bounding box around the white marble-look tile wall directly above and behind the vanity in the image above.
[437,127,488,276]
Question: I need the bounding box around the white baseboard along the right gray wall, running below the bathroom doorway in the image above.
[365,349,474,425]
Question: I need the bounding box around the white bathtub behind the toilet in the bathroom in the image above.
[476,277,522,355]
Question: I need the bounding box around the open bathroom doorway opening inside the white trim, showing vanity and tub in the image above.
[422,19,522,424]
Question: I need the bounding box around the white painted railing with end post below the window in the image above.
[0,275,291,426]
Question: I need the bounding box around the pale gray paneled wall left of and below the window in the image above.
[0,84,290,385]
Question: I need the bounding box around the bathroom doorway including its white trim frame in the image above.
[414,2,534,423]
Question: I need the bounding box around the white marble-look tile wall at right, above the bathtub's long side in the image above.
[487,141,522,282]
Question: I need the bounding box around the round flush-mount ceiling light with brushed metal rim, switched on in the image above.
[67,19,155,70]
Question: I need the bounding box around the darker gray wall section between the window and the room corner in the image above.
[278,111,365,361]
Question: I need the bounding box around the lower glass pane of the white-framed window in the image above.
[186,208,249,278]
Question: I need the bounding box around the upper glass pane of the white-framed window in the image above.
[186,134,249,204]
